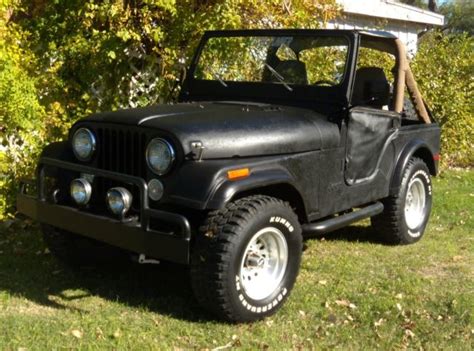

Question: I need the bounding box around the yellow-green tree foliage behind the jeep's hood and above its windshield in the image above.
[14,0,337,120]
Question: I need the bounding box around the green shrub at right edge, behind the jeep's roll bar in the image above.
[412,32,474,166]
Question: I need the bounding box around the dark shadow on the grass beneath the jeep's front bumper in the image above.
[0,224,213,321]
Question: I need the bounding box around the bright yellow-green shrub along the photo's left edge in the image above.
[0,11,45,220]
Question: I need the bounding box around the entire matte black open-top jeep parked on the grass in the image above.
[17,30,440,321]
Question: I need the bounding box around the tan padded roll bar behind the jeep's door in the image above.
[394,39,431,124]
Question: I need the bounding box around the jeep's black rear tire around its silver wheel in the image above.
[371,157,432,245]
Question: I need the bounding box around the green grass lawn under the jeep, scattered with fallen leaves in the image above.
[0,170,474,350]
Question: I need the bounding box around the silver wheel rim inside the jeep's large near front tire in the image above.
[239,227,288,301]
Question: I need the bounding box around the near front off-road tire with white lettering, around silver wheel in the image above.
[191,195,302,322]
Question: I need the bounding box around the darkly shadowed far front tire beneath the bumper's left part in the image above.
[41,224,127,268]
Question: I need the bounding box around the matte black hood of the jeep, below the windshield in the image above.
[84,102,340,159]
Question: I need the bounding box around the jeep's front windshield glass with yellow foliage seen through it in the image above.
[194,35,349,91]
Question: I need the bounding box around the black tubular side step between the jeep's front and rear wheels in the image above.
[302,202,383,235]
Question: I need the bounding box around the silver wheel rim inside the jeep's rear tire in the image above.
[405,178,426,230]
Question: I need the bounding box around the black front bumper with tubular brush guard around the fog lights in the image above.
[17,158,191,264]
